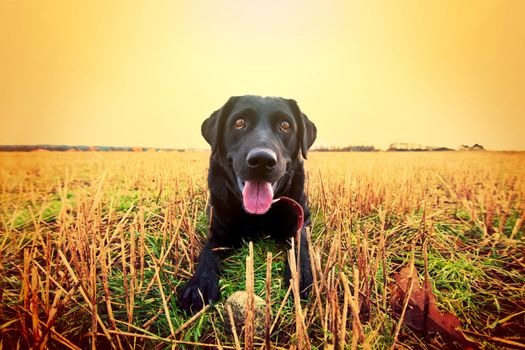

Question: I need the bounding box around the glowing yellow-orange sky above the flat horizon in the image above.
[0,0,525,149]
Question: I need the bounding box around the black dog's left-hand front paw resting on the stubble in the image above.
[179,274,220,314]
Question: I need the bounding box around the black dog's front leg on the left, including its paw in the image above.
[179,240,220,314]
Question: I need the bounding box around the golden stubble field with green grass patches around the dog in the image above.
[0,152,525,349]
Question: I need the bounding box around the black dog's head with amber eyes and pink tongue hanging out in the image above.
[202,96,317,214]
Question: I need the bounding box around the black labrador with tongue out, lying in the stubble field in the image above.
[179,96,317,313]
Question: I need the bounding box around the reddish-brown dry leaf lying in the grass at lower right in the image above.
[390,266,472,345]
